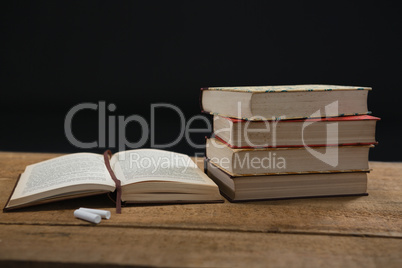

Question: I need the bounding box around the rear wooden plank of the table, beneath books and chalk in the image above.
[0,153,402,237]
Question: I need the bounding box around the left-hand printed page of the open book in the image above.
[12,153,115,198]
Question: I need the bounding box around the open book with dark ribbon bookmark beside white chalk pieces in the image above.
[4,149,223,211]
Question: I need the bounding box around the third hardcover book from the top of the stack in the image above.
[206,138,373,176]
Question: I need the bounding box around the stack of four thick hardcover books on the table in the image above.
[201,85,379,201]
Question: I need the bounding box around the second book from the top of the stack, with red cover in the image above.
[213,115,380,148]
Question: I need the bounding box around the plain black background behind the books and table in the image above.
[0,1,402,161]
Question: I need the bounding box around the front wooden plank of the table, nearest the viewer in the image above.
[0,225,402,267]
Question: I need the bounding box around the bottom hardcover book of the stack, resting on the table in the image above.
[207,159,367,202]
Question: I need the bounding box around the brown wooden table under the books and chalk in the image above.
[0,152,402,267]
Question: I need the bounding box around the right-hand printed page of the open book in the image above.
[111,149,215,185]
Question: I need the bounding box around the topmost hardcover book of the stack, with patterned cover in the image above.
[201,85,371,120]
